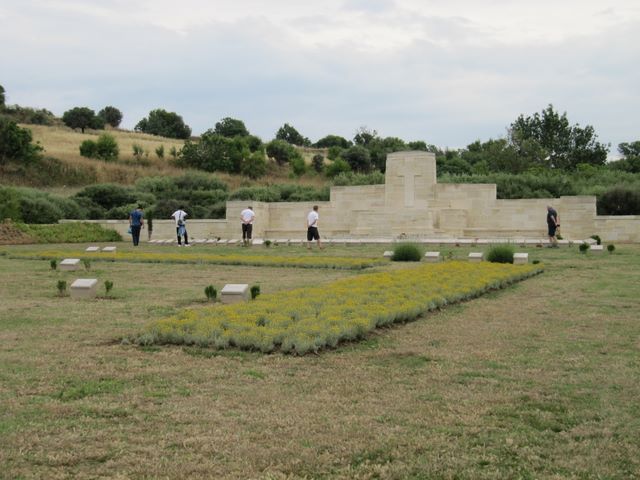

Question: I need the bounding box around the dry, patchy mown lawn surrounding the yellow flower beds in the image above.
[0,243,640,479]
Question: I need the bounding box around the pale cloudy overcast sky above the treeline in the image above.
[0,0,640,154]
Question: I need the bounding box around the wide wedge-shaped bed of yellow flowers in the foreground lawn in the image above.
[135,261,542,354]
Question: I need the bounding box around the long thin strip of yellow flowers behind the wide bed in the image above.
[7,250,387,270]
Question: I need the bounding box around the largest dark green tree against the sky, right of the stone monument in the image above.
[509,105,609,171]
